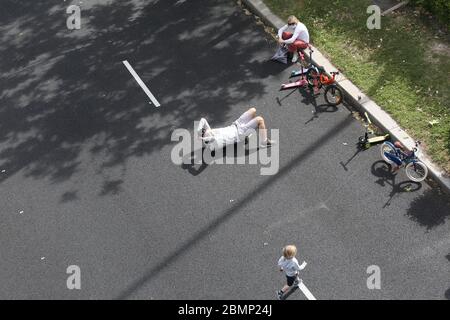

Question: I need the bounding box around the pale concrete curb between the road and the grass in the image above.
[241,0,450,195]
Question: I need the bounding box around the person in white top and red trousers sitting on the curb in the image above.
[278,16,309,62]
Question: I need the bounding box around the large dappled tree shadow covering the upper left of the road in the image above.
[0,0,285,201]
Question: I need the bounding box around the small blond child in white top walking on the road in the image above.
[277,245,306,299]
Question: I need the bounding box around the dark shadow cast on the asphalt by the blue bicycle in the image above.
[371,160,422,209]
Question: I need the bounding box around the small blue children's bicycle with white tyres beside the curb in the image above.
[381,141,428,182]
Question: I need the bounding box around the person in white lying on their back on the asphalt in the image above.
[197,108,275,148]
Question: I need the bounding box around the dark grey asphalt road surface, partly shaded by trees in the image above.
[0,0,450,299]
